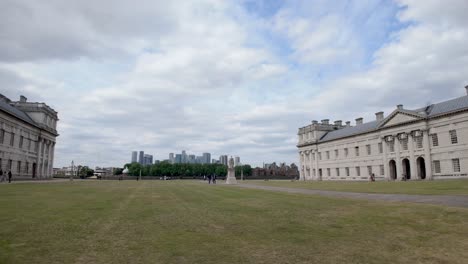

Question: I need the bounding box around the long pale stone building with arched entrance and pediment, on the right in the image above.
[297,86,468,180]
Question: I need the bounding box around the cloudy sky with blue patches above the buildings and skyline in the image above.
[0,0,468,167]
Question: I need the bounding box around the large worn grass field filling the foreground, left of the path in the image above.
[0,181,468,263]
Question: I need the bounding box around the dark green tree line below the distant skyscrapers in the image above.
[120,162,252,177]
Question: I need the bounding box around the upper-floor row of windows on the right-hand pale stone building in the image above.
[304,130,458,160]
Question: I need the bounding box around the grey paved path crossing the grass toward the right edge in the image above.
[236,183,468,208]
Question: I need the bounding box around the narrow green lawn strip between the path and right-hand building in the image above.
[249,179,468,195]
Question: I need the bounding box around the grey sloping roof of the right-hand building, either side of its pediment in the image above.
[319,96,468,142]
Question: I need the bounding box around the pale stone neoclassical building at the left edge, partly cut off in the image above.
[0,94,58,180]
